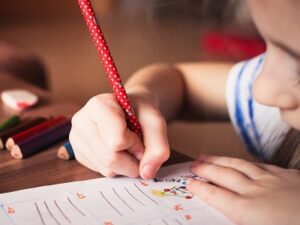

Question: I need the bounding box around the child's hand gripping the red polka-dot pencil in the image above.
[70,94,170,178]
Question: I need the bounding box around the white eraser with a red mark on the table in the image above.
[1,89,38,111]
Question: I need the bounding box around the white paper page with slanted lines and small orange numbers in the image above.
[0,163,232,225]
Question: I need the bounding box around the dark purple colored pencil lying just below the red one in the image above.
[11,120,71,159]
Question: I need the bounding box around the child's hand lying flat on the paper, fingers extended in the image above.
[187,156,300,225]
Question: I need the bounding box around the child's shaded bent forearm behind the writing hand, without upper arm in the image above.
[126,64,185,120]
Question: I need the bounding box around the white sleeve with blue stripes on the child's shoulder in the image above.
[226,54,290,161]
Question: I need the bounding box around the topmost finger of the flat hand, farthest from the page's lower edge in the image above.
[198,155,265,179]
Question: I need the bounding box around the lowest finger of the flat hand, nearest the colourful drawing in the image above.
[187,179,240,222]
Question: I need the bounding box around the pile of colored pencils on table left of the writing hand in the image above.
[0,116,74,160]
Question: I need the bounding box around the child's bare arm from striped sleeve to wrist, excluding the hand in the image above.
[126,63,232,120]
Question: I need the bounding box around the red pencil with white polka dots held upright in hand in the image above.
[78,0,142,137]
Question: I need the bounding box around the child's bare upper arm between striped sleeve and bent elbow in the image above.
[177,62,233,121]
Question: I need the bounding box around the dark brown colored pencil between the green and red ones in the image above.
[0,117,47,149]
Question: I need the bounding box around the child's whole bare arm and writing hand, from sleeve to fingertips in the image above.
[70,63,231,178]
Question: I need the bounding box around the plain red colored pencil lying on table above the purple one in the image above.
[6,116,69,150]
